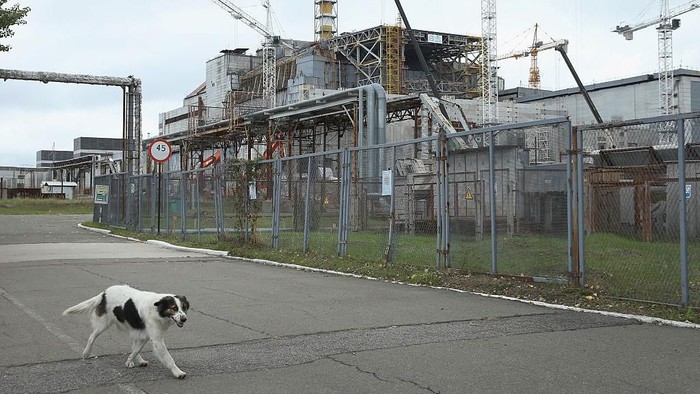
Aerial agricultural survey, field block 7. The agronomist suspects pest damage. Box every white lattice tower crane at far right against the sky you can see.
[612,0,700,115]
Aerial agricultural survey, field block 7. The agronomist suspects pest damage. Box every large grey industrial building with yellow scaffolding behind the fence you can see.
[158,22,546,169]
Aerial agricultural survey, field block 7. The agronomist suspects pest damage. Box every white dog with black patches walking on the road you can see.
[63,285,190,379]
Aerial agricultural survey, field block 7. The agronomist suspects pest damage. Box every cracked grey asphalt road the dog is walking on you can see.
[0,215,700,393]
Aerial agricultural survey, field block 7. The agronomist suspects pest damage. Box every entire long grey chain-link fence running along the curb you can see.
[95,114,700,305]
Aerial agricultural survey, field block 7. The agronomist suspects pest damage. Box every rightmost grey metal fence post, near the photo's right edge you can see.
[676,119,690,306]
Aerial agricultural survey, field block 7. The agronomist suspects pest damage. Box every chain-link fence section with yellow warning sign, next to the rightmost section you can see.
[448,120,571,281]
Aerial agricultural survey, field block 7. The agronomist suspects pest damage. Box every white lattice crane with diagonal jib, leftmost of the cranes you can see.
[212,0,282,108]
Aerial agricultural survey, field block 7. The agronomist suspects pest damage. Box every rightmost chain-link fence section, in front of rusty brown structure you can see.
[578,114,700,305]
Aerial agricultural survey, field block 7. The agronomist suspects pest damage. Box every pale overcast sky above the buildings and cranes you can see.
[0,0,700,167]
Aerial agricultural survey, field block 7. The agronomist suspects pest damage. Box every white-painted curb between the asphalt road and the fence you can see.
[78,224,700,329]
